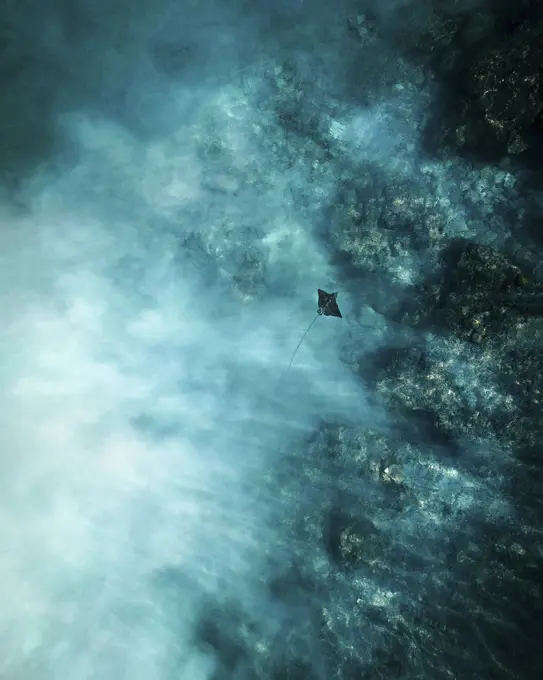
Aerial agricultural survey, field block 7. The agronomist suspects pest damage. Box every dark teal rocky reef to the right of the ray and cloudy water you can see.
[200,2,543,680]
